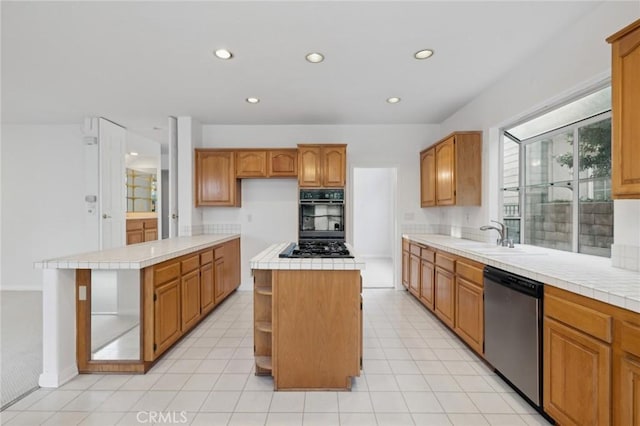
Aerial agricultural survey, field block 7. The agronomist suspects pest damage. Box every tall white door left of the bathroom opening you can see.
[98,118,127,250]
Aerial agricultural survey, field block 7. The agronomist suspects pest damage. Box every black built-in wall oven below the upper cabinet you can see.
[298,189,345,242]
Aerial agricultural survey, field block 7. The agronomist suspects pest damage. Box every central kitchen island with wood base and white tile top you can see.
[251,243,364,390]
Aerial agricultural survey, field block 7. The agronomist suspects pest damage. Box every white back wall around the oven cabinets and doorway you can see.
[199,125,439,289]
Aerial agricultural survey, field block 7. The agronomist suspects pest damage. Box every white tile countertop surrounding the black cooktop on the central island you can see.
[250,243,364,271]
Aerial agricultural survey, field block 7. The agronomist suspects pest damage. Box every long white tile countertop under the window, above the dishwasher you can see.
[403,234,640,313]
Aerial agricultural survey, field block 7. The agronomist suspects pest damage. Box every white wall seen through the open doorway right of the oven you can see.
[352,168,395,257]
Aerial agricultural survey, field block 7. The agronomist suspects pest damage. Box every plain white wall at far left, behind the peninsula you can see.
[1,125,99,290]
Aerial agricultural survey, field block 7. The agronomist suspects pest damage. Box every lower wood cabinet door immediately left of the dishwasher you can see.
[455,277,484,354]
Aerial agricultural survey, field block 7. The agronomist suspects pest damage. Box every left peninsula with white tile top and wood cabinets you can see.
[34,234,240,387]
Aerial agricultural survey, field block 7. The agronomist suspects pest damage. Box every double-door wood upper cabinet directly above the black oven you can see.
[298,144,347,188]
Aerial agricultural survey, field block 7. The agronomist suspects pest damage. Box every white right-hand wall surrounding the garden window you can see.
[440,1,640,258]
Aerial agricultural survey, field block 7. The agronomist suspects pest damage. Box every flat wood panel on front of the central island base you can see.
[272,270,362,390]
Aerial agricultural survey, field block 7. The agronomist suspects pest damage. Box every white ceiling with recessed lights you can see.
[2,1,600,139]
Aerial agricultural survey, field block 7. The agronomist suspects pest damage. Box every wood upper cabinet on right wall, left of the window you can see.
[420,132,482,207]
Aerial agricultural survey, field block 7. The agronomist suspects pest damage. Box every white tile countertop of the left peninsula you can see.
[34,234,240,269]
